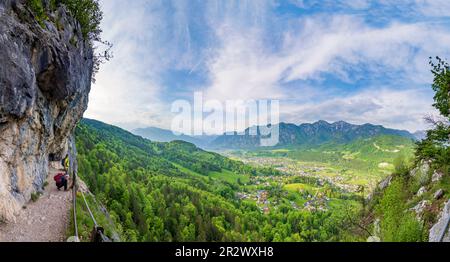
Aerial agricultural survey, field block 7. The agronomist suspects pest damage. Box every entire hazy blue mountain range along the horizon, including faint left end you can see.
[133,120,422,149]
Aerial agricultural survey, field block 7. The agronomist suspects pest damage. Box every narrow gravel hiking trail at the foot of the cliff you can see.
[0,168,72,242]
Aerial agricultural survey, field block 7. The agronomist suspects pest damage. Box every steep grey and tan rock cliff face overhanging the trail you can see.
[0,0,93,221]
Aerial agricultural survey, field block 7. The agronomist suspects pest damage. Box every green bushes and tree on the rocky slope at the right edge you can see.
[370,57,450,242]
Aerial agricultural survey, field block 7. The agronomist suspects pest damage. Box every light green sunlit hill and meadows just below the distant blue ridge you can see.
[243,135,415,185]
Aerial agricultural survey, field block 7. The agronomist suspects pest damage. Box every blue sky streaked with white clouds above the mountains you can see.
[85,0,450,131]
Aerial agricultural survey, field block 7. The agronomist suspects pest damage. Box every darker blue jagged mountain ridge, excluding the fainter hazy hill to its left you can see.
[209,120,416,149]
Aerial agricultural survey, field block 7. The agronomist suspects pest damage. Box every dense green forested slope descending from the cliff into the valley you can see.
[76,119,360,241]
